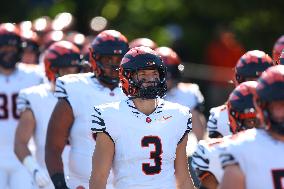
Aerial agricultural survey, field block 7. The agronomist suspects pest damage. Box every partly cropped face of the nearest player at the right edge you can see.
[268,100,284,123]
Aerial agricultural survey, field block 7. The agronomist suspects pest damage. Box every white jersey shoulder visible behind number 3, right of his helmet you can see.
[165,83,204,109]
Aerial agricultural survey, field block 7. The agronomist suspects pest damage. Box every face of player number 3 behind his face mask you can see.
[134,69,160,87]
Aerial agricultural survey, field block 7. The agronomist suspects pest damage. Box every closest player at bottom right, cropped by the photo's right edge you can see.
[220,65,284,189]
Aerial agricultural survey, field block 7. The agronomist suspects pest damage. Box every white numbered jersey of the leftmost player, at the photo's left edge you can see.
[0,63,43,155]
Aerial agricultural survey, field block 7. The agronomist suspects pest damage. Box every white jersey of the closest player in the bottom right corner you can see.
[220,129,284,189]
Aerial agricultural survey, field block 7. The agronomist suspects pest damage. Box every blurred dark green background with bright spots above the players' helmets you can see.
[0,0,284,117]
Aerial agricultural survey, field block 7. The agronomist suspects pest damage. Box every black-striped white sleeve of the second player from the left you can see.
[16,89,31,114]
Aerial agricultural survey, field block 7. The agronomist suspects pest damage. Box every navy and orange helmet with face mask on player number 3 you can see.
[119,47,167,99]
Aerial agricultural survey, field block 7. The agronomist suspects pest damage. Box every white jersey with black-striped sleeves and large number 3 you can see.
[92,99,192,189]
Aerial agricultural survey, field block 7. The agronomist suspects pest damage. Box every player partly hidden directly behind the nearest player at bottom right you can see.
[192,81,259,189]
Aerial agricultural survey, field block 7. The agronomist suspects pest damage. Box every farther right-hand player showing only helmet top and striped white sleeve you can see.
[207,50,274,138]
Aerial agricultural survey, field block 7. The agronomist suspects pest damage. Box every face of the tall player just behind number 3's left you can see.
[100,56,122,78]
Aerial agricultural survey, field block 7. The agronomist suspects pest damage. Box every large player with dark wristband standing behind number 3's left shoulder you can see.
[45,30,129,189]
